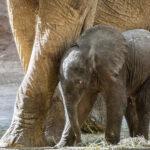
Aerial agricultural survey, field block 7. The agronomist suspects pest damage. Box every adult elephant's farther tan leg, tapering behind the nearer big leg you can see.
[7,0,38,72]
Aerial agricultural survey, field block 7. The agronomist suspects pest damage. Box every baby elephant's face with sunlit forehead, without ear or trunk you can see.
[60,45,90,102]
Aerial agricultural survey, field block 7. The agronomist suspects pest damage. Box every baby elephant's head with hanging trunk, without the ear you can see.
[59,45,90,143]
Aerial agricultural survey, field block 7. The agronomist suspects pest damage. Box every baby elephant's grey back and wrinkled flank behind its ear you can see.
[122,29,150,90]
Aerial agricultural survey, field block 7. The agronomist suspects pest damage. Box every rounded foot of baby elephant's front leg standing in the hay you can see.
[106,133,120,144]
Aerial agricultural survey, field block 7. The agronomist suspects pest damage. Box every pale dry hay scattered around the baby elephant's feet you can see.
[82,134,150,150]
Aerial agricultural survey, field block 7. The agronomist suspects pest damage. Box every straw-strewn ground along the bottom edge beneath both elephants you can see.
[0,134,150,150]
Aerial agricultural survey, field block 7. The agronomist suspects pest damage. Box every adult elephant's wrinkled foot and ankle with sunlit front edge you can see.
[0,114,47,147]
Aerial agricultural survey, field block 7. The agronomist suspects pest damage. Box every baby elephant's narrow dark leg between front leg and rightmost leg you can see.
[125,97,139,137]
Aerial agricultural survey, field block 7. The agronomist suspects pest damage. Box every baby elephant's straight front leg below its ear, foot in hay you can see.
[105,82,126,144]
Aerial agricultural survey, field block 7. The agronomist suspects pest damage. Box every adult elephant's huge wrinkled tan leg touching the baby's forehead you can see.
[0,0,96,147]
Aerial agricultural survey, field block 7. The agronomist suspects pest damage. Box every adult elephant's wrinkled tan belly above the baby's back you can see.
[94,0,150,31]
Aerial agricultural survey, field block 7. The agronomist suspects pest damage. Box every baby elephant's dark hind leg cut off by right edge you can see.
[136,79,150,139]
